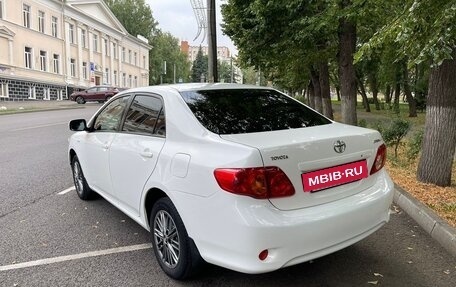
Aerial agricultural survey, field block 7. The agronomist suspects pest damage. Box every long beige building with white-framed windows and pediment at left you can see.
[0,0,151,101]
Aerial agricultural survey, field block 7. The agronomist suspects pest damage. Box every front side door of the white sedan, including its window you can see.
[82,96,130,197]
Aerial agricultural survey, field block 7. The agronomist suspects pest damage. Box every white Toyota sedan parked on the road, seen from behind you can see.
[69,84,393,279]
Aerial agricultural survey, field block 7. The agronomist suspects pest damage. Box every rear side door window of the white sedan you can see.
[122,95,166,136]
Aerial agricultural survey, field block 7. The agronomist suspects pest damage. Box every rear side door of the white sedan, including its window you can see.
[110,94,166,216]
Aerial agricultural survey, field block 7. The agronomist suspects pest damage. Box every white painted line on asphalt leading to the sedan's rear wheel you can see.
[0,243,152,271]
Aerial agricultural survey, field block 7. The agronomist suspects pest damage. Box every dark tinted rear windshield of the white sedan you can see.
[181,89,331,134]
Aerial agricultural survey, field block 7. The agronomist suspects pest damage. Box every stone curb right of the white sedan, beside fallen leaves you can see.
[394,184,456,257]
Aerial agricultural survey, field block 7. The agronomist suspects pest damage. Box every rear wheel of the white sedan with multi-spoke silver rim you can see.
[150,197,204,280]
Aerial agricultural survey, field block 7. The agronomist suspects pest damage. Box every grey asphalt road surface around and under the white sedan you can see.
[0,107,456,287]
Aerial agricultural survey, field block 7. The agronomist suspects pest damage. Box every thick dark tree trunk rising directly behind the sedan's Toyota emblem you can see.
[338,0,358,125]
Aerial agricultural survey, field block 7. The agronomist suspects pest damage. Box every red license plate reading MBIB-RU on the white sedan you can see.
[301,160,367,192]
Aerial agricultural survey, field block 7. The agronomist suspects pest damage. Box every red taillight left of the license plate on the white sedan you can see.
[214,167,295,199]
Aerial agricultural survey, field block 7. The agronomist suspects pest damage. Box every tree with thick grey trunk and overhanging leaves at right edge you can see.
[357,0,456,186]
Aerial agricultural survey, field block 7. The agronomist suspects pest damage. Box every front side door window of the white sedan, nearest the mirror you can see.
[93,96,130,131]
